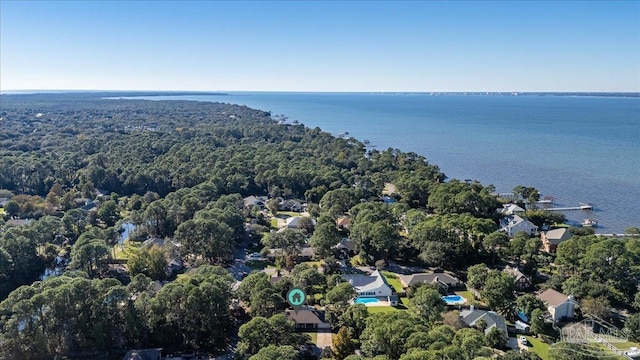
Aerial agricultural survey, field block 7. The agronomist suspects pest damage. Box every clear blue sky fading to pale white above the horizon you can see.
[0,0,640,92]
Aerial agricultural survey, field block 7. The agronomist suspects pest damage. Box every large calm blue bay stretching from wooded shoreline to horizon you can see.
[127,92,640,233]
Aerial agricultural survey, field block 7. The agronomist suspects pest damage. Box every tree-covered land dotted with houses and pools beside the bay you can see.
[0,92,640,360]
